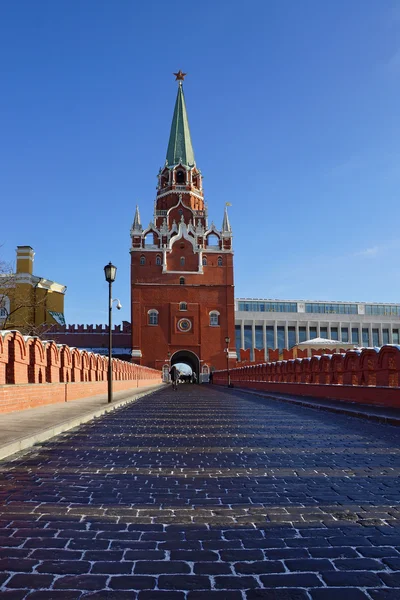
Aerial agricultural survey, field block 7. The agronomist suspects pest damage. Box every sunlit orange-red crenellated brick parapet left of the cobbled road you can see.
[0,331,161,413]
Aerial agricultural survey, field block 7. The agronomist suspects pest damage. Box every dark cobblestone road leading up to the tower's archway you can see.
[0,385,400,600]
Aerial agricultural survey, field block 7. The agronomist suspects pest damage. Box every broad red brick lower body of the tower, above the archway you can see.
[131,252,236,369]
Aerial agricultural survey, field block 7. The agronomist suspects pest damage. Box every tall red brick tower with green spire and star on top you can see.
[130,71,236,380]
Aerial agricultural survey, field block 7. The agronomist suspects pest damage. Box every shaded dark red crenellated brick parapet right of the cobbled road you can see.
[213,345,400,408]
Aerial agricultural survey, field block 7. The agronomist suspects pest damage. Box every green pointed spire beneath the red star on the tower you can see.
[167,81,195,167]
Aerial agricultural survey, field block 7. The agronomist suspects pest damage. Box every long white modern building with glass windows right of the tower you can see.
[235,298,400,360]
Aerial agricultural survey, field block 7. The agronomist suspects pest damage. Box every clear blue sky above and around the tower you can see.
[0,0,400,323]
